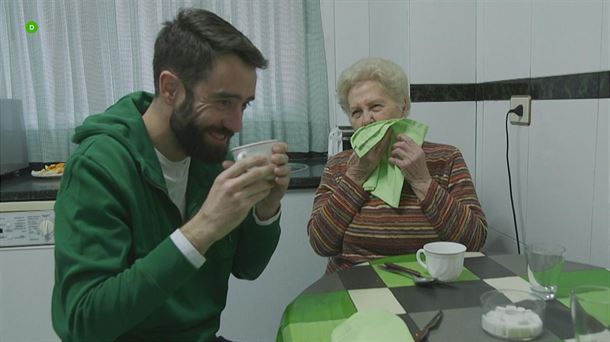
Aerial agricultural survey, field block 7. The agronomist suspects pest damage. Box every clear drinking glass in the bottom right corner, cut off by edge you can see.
[570,285,610,342]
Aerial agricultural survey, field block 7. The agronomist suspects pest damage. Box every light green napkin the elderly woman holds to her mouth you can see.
[351,119,428,208]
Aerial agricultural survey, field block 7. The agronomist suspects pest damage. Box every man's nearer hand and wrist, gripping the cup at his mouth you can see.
[180,157,274,255]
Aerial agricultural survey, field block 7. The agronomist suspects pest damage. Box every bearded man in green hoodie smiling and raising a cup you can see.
[52,9,290,341]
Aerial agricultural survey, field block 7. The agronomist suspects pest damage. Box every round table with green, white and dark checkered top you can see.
[277,252,610,342]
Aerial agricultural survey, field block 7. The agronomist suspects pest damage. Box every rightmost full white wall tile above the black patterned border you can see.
[532,0,603,77]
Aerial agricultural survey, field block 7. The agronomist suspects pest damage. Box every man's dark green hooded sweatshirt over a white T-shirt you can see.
[52,92,280,341]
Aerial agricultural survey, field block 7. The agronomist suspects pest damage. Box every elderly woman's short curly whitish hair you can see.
[337,57,411,115]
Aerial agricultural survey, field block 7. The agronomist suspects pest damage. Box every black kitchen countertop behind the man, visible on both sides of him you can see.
[0,156,326,202]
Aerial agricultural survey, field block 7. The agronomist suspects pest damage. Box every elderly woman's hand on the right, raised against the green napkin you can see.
[389,134,432,201]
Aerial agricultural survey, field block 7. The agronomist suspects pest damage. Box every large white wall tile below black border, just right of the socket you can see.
[525,100,598,262]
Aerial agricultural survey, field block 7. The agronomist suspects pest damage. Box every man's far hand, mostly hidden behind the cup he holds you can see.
[256,142,290,221]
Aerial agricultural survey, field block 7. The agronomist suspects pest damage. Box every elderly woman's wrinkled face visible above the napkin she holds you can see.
[347,81,407,130]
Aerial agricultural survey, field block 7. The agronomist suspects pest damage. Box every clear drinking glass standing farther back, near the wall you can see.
[525,243,566,300]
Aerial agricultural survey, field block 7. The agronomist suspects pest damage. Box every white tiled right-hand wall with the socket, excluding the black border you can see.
[477,0,610,267]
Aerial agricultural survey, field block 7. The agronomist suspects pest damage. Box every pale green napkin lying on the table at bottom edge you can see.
[330,310,413,342]
